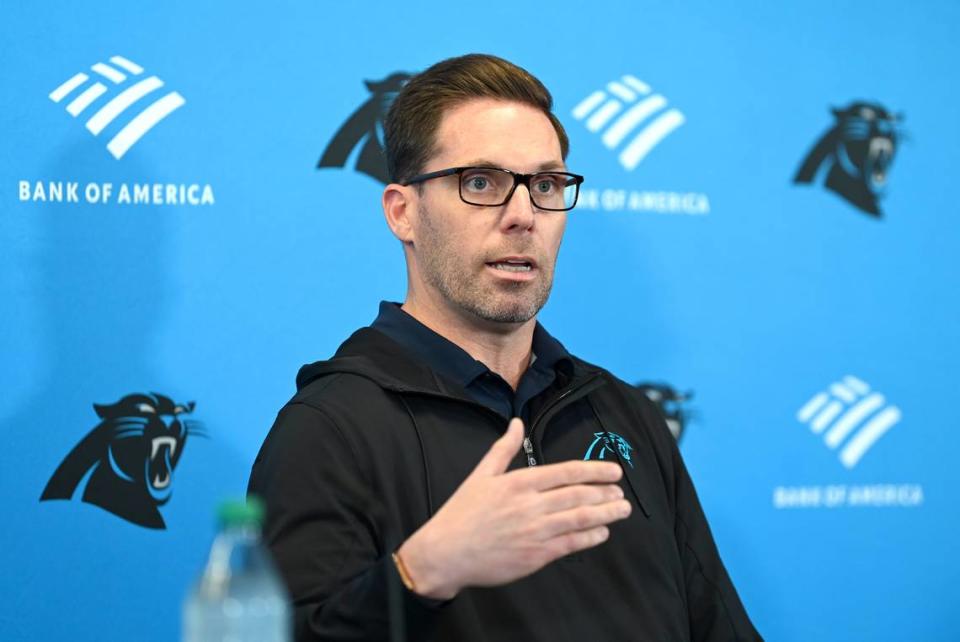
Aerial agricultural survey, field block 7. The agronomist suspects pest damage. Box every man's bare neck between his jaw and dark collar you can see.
[400,296,537,390]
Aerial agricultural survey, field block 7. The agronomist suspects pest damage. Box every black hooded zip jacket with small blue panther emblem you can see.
[249,328,760,642]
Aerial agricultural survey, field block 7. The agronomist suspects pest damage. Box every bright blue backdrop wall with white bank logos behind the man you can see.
[0,0,960,641]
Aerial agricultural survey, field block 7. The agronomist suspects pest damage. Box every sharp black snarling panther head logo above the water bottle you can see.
[40,393,203,528]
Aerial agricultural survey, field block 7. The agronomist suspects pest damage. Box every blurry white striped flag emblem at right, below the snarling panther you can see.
[797,375,900,468]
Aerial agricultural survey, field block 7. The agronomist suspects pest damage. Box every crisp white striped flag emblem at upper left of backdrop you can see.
[50,56,187,160]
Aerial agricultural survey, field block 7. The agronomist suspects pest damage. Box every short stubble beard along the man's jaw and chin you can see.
[418,204,553,323]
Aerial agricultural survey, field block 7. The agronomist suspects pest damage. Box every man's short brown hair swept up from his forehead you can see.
[384,54,570,183]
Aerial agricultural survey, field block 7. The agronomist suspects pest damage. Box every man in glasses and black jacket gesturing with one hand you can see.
[249,55,759,642]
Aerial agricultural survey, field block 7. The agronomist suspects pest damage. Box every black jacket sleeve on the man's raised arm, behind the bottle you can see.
[247,403,438,642]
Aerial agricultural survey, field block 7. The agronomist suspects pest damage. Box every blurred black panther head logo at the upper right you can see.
[793,102,903,218]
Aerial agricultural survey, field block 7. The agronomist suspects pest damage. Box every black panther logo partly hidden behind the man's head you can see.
[317,72,410,185]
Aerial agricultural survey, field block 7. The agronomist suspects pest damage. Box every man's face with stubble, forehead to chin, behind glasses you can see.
[411,99,566,323]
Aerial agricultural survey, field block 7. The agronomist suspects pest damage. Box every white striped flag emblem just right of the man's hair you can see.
[573,75,686,171]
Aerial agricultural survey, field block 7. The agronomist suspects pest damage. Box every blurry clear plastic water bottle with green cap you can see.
[183,499,292,642]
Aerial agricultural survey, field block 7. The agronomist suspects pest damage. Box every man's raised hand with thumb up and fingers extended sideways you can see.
[397,419,631,599]
